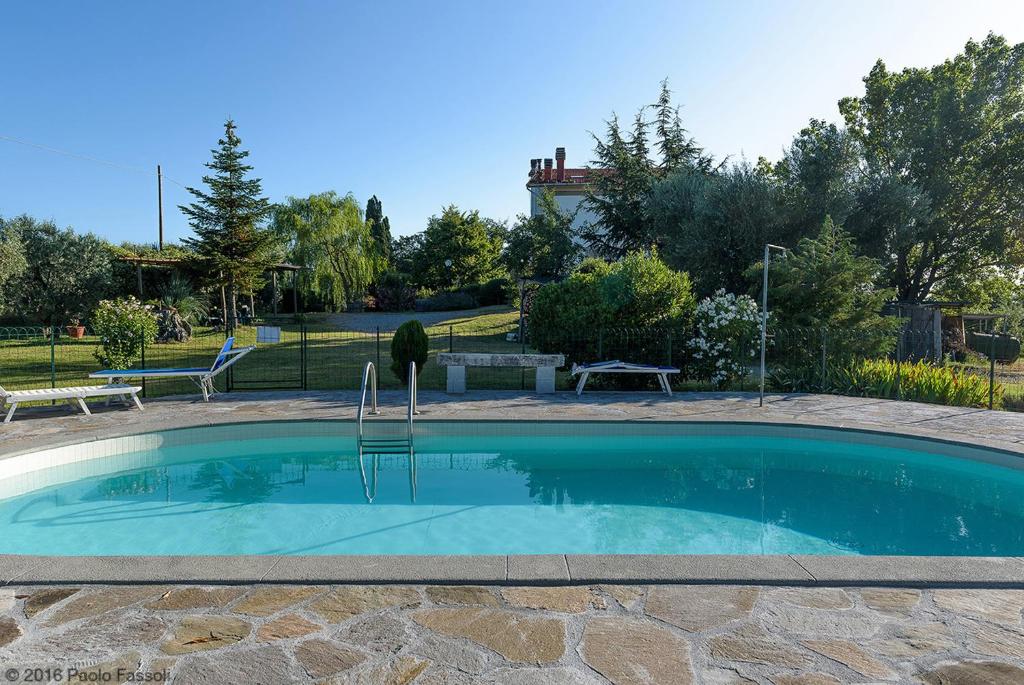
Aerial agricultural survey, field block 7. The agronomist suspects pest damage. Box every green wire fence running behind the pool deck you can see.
[0,319,1024,411]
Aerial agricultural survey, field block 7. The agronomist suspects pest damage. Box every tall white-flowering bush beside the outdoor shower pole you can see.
[688,290,761,388]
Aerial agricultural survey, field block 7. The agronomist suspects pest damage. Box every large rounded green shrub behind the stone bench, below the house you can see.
[527,252,695,370]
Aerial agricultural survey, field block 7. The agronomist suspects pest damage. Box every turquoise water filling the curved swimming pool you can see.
[0,422,1024,556]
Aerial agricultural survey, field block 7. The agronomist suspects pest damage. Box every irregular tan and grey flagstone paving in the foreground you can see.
[0,585,1024,685]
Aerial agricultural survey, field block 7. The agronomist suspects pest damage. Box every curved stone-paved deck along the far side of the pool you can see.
[6,390,1024,458]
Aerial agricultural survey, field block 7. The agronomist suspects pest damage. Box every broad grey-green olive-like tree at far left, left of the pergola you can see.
[2,215,113,326]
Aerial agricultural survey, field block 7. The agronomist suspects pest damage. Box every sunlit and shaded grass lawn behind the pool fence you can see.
[0,307,567,397]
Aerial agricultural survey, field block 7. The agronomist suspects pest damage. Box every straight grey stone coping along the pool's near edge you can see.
[0,554,1024,588]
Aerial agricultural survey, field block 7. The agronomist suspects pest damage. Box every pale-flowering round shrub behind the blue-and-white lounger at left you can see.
[91,296,157,369]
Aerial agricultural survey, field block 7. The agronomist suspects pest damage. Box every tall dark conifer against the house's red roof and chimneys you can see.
[583,81,713,259]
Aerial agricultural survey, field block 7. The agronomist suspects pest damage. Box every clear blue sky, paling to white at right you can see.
[0,0,1024,242]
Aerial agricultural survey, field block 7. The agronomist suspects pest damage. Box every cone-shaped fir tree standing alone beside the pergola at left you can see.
[179,119,280,322]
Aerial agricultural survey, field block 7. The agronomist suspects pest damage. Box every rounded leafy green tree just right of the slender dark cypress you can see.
[412,205,506,289]
